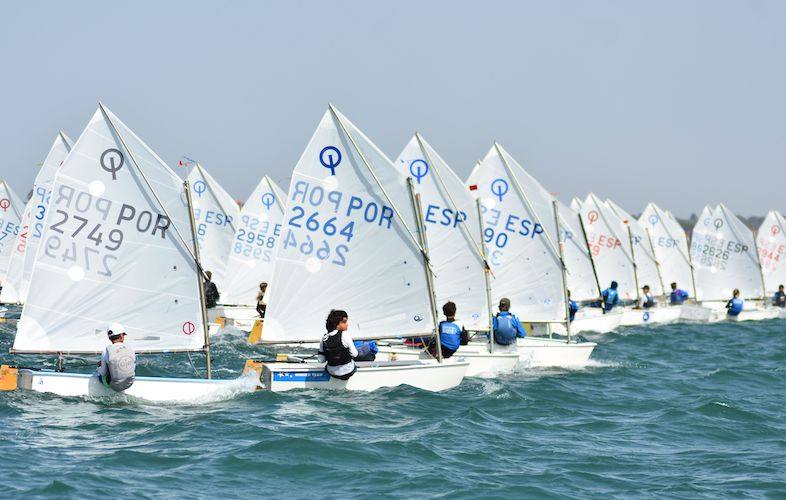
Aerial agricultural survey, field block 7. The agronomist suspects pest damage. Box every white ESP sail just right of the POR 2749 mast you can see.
[188,163,240,288]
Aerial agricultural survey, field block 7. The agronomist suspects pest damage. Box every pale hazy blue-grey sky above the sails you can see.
[0,0,786,216]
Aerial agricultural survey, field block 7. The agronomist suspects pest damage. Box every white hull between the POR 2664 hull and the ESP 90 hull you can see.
[377,344,519,377]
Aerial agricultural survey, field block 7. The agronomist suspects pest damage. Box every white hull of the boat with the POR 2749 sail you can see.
[18,369,258,402]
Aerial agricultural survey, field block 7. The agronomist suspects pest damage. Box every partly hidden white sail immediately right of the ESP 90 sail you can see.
[559,202,600,301]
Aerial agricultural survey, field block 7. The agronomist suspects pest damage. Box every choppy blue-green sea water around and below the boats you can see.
[0,320,786,498]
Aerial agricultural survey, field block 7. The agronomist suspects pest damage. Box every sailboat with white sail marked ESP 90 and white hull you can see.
[467,143,595,367]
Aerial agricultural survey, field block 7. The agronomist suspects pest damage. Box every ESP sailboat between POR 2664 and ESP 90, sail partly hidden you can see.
[380,133,519,377]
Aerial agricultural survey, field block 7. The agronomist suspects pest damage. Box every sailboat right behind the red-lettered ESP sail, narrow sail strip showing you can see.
[606,199,682,326]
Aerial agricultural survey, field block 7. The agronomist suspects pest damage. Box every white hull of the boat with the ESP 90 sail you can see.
[466,337,597,368]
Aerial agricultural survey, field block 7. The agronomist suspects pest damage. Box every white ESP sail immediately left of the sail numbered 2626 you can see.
[639,203,696,296]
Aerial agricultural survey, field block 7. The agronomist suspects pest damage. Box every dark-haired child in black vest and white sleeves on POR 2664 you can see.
[317,309,358,380]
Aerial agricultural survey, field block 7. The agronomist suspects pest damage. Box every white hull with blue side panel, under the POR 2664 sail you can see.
[262,358,469,392]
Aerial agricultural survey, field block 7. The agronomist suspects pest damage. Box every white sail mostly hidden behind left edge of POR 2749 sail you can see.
[7,132,73,302]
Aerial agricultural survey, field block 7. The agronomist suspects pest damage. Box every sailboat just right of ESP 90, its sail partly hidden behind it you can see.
[552,203,622,335]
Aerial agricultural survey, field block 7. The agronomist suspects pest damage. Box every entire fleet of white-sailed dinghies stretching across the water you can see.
[0,105,786,401]
